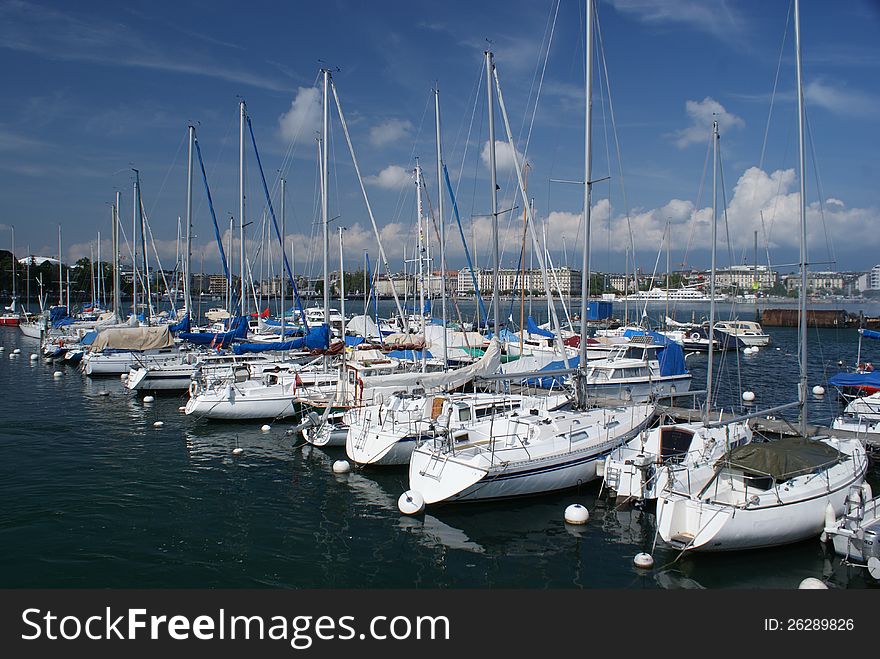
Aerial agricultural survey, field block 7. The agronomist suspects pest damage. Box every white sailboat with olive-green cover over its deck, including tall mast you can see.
[657,0,868,551]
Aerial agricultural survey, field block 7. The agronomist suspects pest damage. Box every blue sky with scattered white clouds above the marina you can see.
[0,0,880,276]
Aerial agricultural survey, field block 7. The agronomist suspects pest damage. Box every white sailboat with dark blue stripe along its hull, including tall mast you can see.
[409,6,655,505]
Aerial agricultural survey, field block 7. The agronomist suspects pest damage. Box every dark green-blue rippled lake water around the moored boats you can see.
[0,303,880,588]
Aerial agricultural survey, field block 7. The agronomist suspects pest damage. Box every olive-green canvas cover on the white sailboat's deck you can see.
[716,437,844,482]
